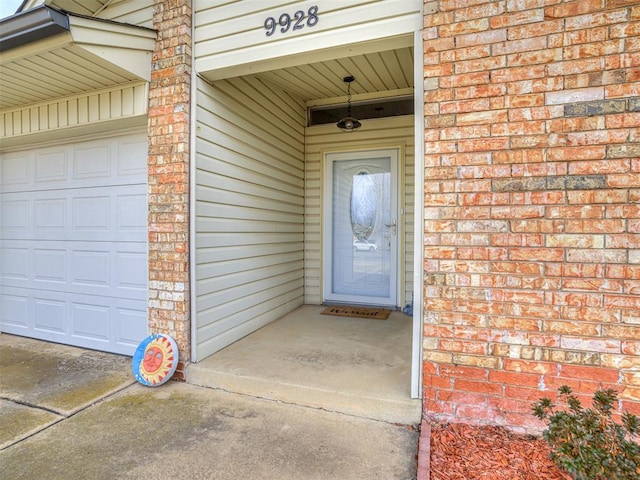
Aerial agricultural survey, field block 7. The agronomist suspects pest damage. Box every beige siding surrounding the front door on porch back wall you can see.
[304,115,415,307]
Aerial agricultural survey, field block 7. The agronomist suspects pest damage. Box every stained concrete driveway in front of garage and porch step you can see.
[0,335,418,480]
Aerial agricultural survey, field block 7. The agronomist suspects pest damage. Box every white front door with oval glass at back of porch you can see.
[323,149,398,307]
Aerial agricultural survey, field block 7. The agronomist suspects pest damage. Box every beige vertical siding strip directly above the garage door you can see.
[0,82,148,145]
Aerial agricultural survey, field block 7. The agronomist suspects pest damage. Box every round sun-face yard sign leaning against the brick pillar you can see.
[131,333,178,387]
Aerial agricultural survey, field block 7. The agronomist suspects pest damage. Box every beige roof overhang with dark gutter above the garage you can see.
[0,5,156,110]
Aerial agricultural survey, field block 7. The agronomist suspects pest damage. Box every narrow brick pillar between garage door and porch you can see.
[148,0,191,379]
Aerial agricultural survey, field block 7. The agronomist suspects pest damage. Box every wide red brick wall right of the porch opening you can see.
[423,0,640,436]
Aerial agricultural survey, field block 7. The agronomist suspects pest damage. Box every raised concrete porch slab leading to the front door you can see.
[186,305,422,425]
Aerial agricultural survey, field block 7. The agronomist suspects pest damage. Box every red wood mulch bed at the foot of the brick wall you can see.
[430,424,570,480]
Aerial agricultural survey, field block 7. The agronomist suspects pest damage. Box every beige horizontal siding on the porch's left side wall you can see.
[195,78,305,360]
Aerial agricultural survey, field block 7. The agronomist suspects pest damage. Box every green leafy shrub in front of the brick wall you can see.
[533,386,640,480]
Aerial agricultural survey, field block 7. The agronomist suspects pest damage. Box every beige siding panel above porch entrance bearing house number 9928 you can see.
[194,0,422,78]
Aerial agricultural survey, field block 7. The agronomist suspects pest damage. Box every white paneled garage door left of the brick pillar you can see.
[0,133,147,355]
